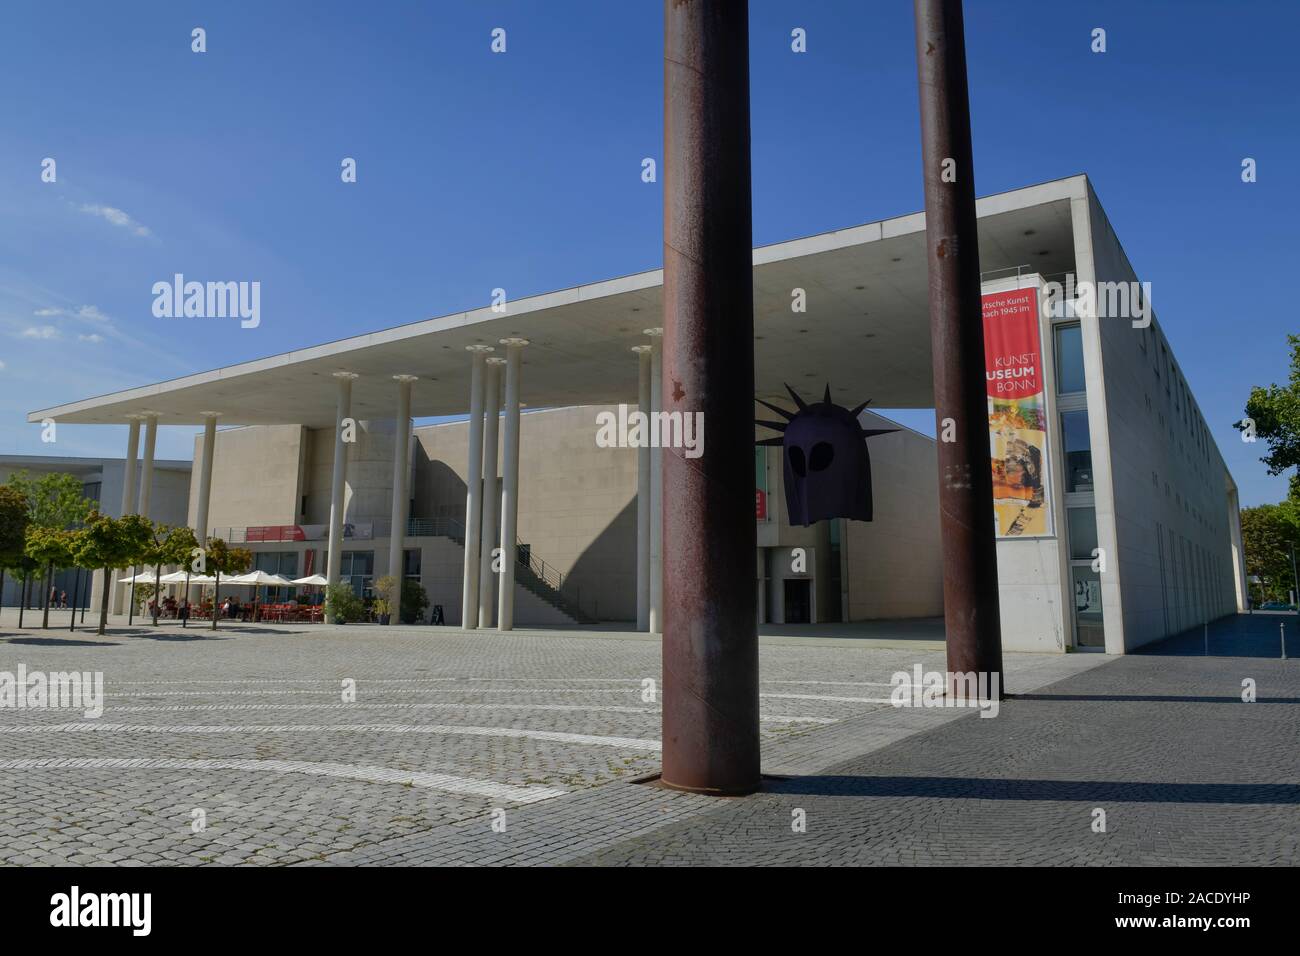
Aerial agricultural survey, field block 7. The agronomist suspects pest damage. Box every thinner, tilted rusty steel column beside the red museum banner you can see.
[915,0,1002,693]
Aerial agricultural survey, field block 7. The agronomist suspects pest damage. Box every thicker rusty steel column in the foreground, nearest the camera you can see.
[662,0,759,795]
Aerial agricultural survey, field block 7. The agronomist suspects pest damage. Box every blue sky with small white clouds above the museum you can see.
[0,0,1300,505]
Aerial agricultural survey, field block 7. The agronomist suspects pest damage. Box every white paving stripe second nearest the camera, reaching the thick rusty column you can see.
[0,723,660,752]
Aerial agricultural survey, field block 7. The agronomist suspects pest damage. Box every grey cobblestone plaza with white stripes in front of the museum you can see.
[0,609,1300,866]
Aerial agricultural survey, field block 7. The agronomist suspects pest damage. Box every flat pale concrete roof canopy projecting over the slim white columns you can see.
[27,176,1087,428]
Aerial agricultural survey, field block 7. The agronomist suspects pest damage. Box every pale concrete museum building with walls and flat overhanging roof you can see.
[29,176,1244,654]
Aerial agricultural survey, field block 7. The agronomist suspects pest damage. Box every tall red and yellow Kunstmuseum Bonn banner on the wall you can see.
[983,289,1053,538]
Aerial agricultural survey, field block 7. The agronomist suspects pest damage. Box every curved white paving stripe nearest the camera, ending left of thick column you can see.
[0,757,567,804]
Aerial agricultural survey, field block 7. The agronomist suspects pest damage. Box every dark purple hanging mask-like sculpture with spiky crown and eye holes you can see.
[755,385,898,527]
